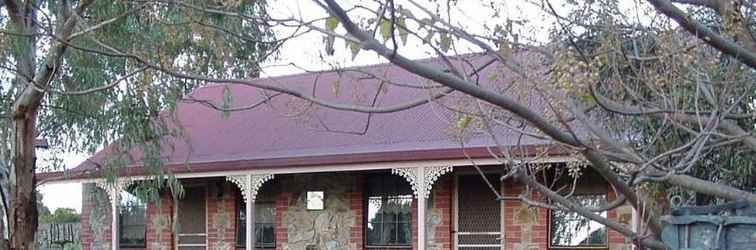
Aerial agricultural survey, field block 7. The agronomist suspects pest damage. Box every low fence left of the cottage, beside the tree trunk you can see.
[35,222,81,250]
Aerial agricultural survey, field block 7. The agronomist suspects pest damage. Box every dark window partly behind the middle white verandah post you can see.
[236,197,276,248]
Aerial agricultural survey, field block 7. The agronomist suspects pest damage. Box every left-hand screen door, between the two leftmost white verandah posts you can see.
[176,186,207,250]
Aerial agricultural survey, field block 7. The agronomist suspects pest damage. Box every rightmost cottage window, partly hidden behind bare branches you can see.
[549,194,607,248]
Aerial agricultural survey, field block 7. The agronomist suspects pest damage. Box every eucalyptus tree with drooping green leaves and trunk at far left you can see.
[0,0,279,249]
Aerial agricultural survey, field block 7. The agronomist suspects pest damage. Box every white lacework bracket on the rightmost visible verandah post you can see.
[391,166,453,198]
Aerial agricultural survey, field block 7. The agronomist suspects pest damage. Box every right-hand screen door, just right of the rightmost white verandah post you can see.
[454,174,501,250]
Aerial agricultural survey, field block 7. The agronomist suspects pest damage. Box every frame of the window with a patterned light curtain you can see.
[362,173,415,249]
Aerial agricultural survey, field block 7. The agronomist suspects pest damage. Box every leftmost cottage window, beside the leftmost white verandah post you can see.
[118,191,147,247]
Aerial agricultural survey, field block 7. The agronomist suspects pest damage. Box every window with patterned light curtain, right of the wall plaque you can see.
[365,175,412,247]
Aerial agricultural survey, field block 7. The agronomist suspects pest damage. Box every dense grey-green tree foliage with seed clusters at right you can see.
[554,1,756,205]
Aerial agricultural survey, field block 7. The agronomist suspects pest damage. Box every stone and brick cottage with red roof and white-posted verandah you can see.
[38,53,635,250]
